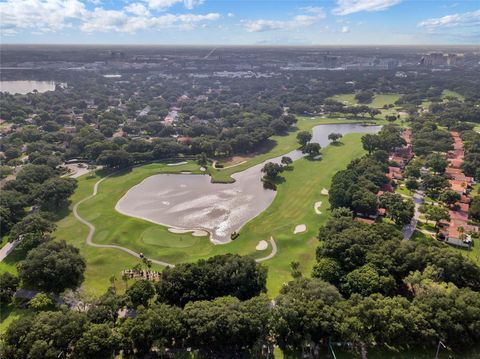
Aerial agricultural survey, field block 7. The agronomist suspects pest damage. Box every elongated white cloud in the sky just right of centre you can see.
[243,7,325,32]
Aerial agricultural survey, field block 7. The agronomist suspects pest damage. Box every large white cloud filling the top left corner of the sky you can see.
[0,0,87,34]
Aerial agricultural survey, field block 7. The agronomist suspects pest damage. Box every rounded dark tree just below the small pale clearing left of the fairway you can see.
[36,177,77,210]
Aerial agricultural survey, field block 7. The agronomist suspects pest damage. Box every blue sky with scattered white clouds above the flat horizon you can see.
[0,0,480,45]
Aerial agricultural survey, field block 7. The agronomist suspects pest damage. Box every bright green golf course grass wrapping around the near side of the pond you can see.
[55,134,364,296]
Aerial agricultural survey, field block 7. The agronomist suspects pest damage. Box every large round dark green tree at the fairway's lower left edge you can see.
[18,241,85,293]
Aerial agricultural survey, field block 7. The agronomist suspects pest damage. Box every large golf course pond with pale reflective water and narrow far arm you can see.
[115,124,381,244]
